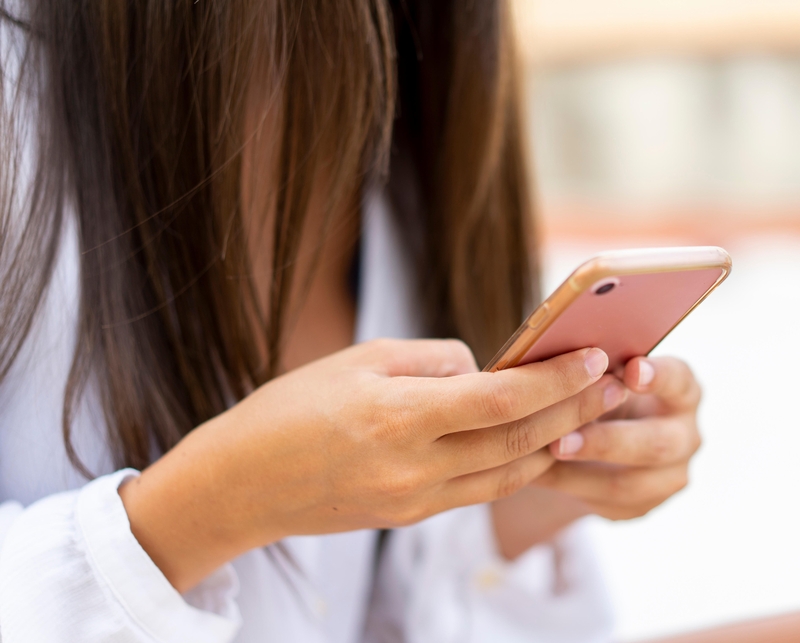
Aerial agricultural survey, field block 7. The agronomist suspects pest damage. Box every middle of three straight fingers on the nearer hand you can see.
[440,376,628,477]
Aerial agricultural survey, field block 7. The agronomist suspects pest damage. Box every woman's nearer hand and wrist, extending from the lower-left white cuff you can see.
[120,340,626,591]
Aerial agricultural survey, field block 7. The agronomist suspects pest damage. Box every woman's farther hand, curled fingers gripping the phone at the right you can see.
[533,357,701,520]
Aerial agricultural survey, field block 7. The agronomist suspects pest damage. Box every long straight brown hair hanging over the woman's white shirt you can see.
[0,0,536,475]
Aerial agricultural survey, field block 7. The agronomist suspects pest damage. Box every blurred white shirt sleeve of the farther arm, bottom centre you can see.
[365,505,613,643]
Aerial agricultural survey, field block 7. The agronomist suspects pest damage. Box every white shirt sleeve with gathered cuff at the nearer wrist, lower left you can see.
[0,469,241,643]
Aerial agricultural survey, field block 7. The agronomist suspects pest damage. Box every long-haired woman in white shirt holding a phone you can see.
[0,0,699,643]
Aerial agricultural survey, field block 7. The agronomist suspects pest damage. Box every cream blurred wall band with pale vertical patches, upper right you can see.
[529,56,800,214]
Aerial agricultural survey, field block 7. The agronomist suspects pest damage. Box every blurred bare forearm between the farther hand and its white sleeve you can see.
[492,486,589,560]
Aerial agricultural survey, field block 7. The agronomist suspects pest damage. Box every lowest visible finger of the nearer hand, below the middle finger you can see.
[440,450,554,511]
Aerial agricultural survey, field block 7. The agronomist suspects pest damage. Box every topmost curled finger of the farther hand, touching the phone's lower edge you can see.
[623,357,701,410]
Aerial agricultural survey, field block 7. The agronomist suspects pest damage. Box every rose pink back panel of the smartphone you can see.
[518,268,724,370]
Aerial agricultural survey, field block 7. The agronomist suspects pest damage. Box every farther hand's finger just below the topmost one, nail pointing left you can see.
[550,414,700,467]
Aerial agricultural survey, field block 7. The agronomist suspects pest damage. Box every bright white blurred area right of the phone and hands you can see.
[545,236,800,643]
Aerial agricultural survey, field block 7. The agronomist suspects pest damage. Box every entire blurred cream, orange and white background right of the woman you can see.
[514,0,800,641]
